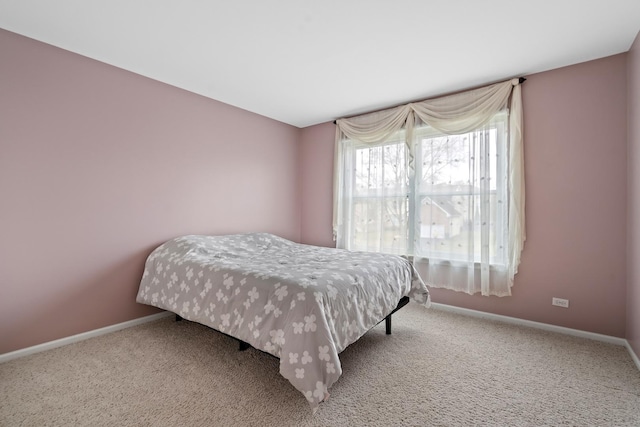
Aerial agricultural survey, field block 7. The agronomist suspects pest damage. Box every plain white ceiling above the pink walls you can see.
[0,0,640,127]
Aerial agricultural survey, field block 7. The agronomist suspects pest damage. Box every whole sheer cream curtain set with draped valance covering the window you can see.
[334,79,525,296]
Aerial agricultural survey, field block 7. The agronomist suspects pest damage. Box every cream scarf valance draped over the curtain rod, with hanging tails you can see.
[333,78,525,295]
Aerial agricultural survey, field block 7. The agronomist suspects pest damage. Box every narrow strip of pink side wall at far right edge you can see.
[627,33,640,356]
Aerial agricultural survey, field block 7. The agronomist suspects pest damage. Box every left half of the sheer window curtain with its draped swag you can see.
[333,106,413,254]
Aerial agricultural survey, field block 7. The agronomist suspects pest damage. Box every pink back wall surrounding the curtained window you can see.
[301,54,640,337]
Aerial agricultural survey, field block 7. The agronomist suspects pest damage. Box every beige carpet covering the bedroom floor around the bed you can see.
[0,304,640,426]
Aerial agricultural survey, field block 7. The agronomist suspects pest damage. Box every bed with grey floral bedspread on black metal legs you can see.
[136,233,429,411]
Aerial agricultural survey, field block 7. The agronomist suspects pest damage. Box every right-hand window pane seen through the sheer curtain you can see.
[415,125,507,263]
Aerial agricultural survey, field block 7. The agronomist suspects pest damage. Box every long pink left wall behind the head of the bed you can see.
[0,30,301,353]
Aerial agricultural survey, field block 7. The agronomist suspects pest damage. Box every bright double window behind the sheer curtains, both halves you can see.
[343,114,507,264]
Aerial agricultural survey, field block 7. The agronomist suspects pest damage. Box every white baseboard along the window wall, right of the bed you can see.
[431,303,640,350]
